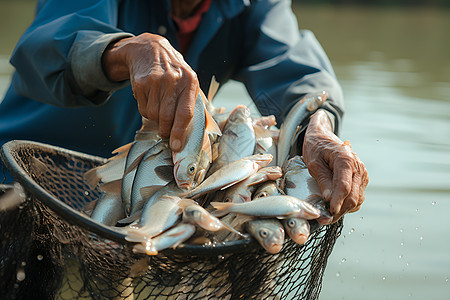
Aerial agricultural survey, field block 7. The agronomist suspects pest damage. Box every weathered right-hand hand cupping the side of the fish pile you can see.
[303,110,369,225]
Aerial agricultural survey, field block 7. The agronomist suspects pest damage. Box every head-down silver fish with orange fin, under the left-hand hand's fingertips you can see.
[172,93,221,190]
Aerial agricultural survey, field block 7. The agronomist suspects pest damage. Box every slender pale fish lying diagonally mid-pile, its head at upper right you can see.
[183,154,273,198]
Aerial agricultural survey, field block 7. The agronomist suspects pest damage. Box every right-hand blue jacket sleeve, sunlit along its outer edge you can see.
[235,0,344,133]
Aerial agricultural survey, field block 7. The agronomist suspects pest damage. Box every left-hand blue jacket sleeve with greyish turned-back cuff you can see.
[11,0,132,107]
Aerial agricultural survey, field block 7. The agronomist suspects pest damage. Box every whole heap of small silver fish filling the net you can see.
[85,88,331,255]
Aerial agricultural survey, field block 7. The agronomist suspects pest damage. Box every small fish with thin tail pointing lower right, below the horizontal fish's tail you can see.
[183,201,245,238]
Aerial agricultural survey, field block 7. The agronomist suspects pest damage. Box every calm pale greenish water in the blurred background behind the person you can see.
[0,1,450,300]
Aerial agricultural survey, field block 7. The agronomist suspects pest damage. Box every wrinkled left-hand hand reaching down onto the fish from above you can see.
[102,33,199,151]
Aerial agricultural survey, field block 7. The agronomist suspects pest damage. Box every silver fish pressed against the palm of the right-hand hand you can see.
[280,155,333,224]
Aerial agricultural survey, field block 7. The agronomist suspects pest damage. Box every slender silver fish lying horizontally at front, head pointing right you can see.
[211,195,320,220]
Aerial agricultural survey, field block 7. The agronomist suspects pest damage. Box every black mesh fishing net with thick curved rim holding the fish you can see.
[0,141,342,299]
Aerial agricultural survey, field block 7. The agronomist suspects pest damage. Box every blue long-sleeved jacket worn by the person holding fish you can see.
[0,0,343,181]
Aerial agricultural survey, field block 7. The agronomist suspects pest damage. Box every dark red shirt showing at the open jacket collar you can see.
[172,0,212,54]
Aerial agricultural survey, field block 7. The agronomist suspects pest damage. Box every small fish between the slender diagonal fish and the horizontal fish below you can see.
[223,166,283,203]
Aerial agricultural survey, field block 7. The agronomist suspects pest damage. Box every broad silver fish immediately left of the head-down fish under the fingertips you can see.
[130,140,173,214]
